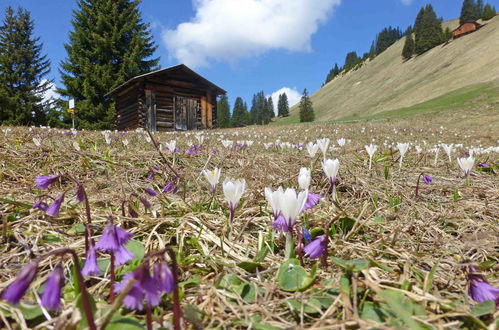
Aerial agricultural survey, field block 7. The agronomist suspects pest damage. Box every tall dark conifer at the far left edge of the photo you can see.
[0,6,52,125]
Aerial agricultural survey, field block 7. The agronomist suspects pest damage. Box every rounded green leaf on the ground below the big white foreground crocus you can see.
[277,258,317,292]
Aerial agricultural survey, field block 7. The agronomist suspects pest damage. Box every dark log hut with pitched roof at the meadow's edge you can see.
[107,64,225,131]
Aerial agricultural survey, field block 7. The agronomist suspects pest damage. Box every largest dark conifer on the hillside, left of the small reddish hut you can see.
[414,5,444,54]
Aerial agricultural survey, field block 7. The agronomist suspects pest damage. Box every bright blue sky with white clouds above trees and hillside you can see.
[0,0,499,111]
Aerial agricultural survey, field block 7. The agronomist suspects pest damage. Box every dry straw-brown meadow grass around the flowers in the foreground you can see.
[0,122,499,329]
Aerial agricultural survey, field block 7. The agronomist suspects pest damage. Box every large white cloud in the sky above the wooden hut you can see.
[162,0,341,67]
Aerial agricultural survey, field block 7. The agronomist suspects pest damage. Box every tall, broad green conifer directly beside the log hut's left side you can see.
[59,0,159,129]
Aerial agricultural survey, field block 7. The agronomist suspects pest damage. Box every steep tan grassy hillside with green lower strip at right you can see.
[277,17,499,124]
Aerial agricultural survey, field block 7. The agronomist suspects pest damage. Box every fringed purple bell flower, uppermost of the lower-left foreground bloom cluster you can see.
[95,223,134,266]
